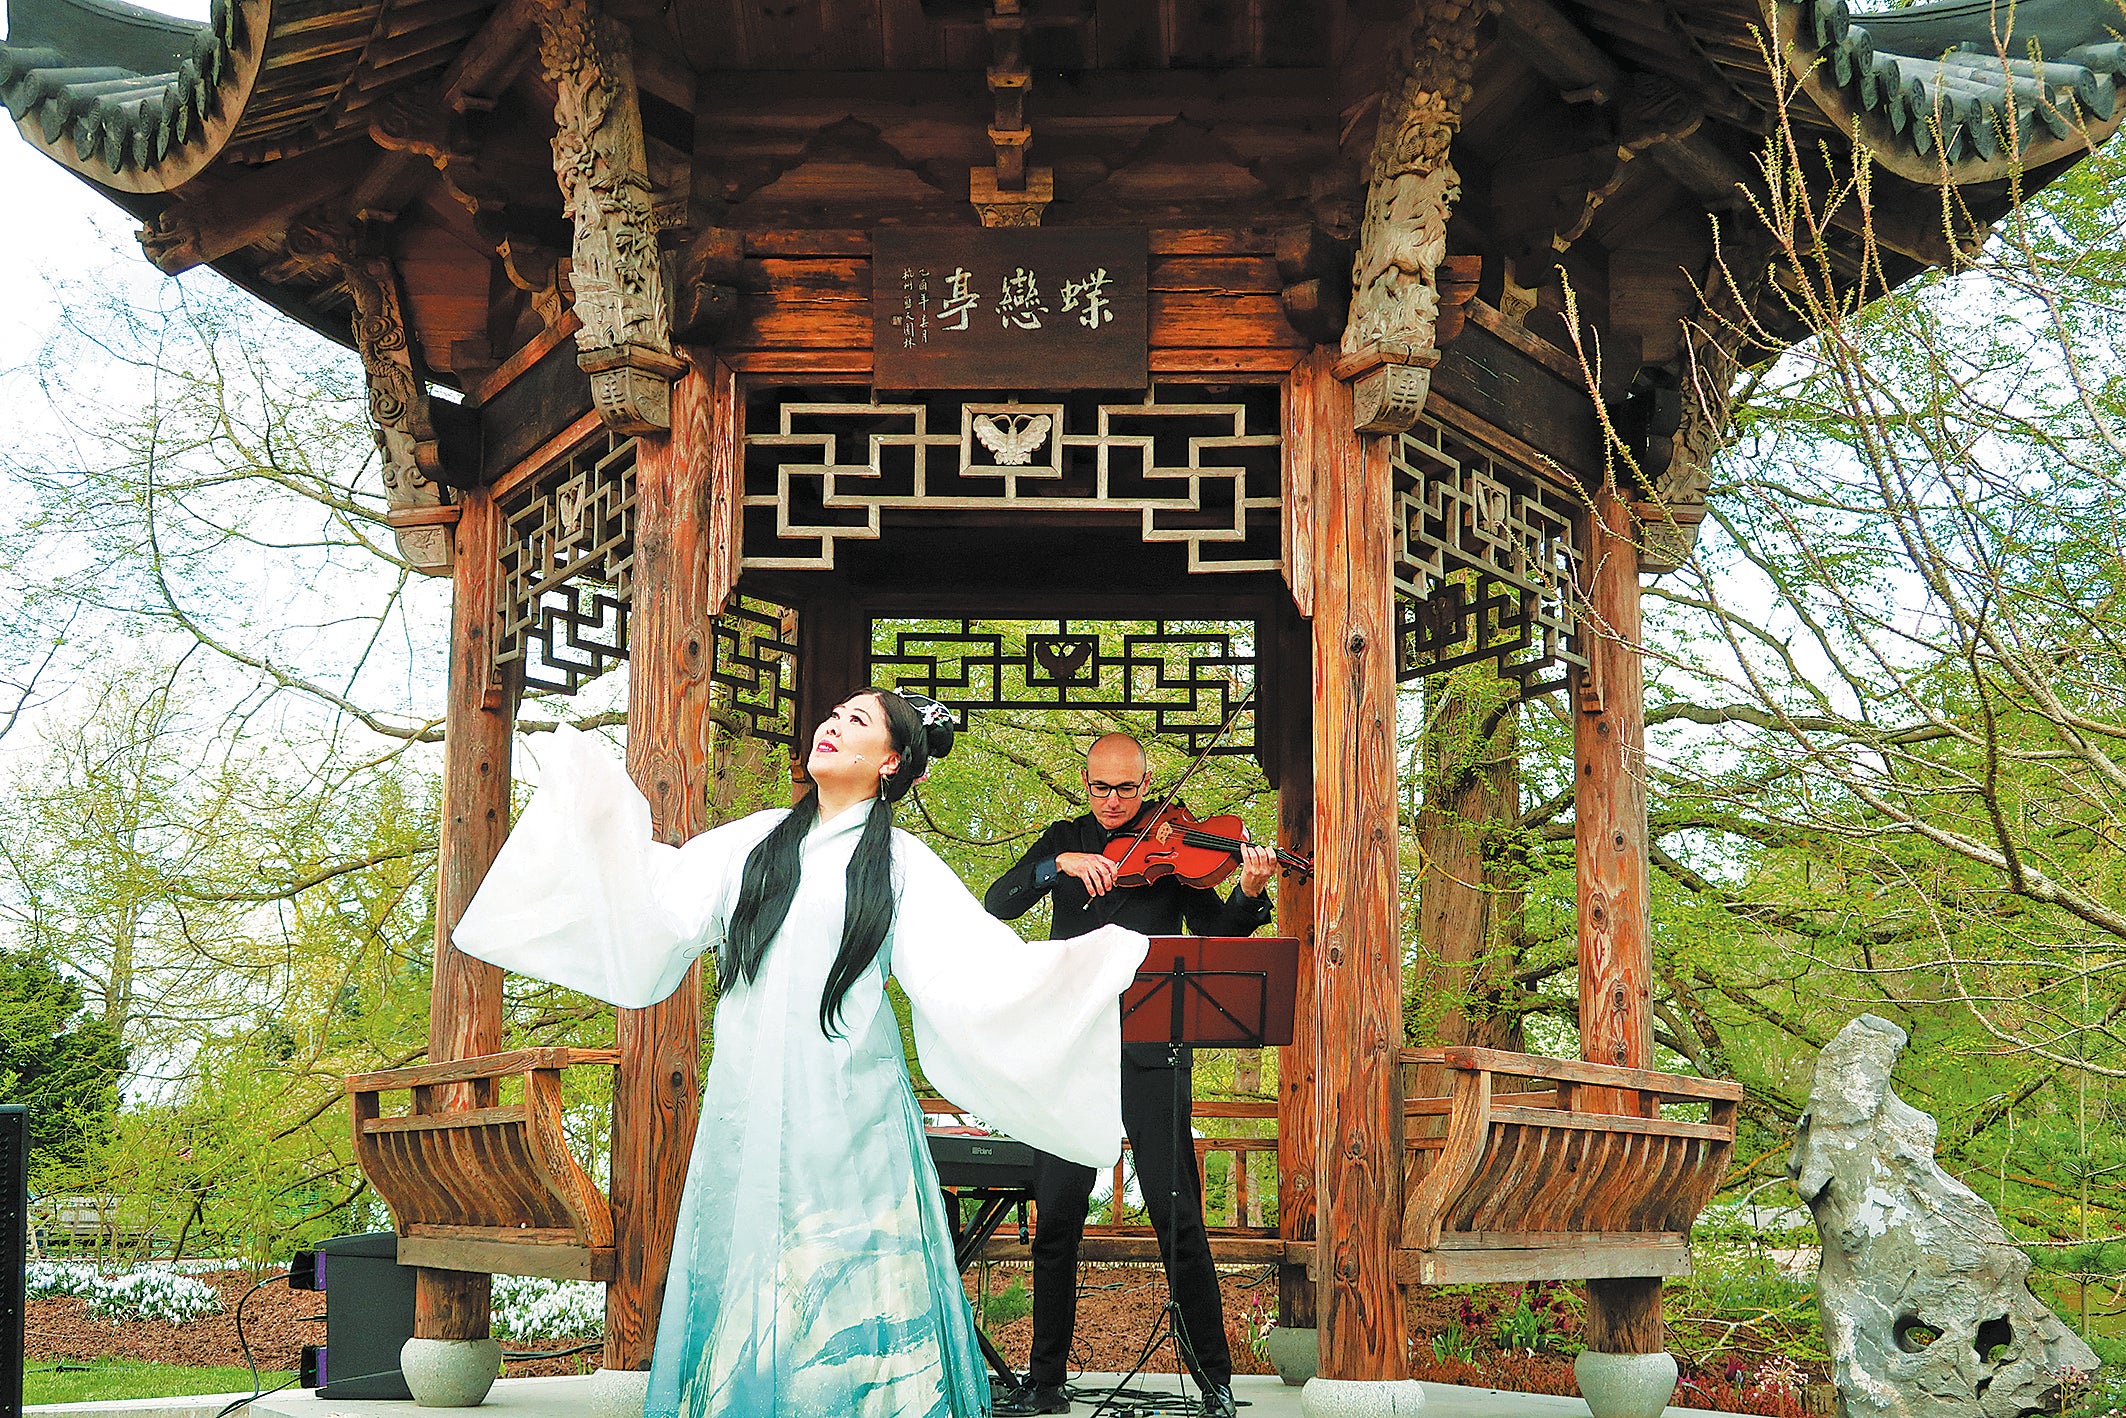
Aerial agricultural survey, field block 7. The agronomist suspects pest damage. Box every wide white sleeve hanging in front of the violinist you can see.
[893,833,1150,1167]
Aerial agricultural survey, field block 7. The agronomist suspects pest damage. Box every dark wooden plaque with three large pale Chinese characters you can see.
[872,227,1148,389]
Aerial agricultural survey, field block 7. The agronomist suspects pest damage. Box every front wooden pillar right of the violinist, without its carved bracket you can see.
[1314,370,1407,1382]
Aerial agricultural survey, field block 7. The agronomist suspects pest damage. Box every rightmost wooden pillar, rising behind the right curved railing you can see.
[1573,487,1665,1354]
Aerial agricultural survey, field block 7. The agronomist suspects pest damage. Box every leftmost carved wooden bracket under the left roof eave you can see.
[281,213,451,576]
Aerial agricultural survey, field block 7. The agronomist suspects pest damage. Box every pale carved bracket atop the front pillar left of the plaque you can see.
[538,0,685,434]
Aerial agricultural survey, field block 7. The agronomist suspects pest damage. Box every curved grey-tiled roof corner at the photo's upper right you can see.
[1777,0,2126,183]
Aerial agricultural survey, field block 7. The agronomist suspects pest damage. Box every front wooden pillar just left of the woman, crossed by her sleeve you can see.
[604,364,727,1369]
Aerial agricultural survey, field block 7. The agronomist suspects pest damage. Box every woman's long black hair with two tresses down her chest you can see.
[716,685,952,1037]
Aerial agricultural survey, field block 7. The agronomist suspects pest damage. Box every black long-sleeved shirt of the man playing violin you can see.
[982,804,1271,1065]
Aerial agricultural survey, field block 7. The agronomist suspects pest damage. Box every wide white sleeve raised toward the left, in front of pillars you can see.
[451,727,782,1010]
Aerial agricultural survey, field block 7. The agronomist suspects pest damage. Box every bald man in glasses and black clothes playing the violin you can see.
[982,733,1278,1418]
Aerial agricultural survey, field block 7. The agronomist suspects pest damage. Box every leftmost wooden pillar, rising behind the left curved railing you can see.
[412,491,517,1339]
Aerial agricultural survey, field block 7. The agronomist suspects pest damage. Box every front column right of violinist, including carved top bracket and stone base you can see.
[1310,0,1480,1414]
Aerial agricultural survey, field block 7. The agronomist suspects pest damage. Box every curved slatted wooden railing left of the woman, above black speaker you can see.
[347,1048,621,1280]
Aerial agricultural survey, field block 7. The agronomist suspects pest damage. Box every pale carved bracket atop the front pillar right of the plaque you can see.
[1344,0,1482,434]
